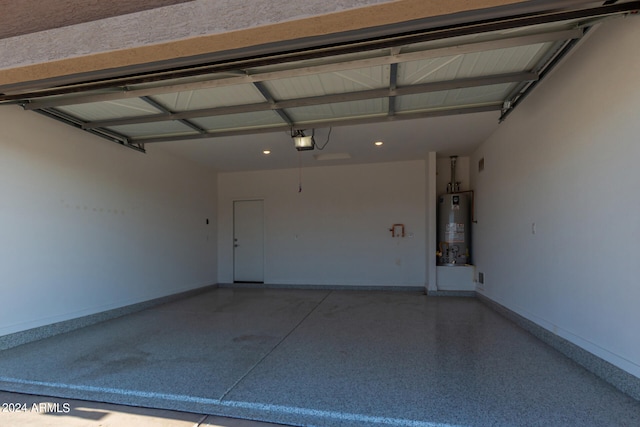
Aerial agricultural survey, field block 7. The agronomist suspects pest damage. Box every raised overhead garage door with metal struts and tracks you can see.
[0,2,640,151]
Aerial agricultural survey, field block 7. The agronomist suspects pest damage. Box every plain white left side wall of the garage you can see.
[0,106,217,335]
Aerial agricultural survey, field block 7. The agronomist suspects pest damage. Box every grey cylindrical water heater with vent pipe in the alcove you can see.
[436,156,471,266]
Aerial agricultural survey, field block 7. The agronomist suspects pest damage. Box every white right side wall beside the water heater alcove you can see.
[471,18,640,377]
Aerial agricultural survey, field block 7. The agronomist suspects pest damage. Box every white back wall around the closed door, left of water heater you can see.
[218,160,426,286]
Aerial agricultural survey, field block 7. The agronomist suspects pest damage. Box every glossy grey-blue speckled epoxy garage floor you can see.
[0,288,640,427]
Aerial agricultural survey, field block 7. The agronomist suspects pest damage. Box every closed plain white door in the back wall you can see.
[233,200,264,283]
